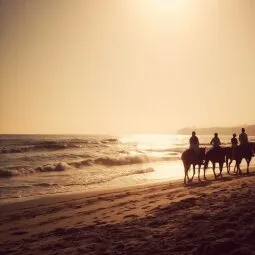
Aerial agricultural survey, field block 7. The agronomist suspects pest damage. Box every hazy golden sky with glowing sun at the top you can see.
[0,0,255,134]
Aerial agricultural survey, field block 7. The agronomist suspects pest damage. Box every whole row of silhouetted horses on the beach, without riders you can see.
[181,143,255,184]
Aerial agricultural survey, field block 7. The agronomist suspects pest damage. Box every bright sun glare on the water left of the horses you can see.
[120,134,187,182]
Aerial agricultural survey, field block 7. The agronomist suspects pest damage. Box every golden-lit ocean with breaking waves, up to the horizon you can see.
[0,134,255,203]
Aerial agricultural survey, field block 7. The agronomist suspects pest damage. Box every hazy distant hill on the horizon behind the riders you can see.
[178,125,255,136]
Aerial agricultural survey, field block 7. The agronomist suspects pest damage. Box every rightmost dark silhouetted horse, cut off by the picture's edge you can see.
[235,143,255,174]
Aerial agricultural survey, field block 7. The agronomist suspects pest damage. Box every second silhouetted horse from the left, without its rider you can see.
[204,147,225,179]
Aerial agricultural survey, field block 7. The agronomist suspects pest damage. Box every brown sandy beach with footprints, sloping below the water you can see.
[0,172,255,255]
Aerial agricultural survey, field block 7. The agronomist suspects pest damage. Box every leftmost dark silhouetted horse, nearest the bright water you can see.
[181,148,205,184]
